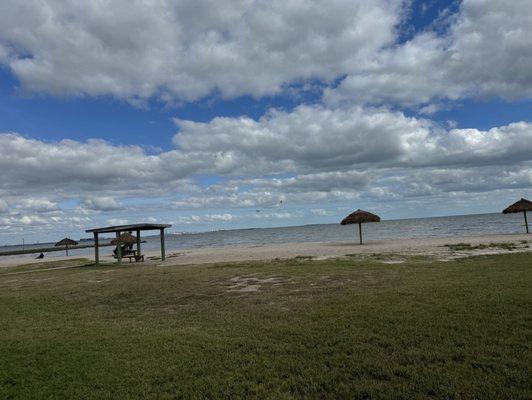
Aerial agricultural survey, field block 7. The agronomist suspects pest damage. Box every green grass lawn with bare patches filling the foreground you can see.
[0,253,532,399]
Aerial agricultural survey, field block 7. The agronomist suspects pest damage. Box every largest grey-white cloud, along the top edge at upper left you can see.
[0,0,402,101]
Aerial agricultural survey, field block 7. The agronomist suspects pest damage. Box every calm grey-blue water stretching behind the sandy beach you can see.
[0,213,524,258]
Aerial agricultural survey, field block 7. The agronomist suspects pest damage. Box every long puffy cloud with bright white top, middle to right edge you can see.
[174,105,532,173]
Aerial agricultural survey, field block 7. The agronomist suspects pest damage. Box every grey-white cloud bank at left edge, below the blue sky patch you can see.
[0,133,198,197]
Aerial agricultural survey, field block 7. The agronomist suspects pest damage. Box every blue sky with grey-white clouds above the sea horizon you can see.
[0,0,532,245]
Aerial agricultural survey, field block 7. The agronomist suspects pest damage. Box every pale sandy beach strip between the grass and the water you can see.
[0,234,532,267]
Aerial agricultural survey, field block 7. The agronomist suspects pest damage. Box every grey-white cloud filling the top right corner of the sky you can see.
[325,0,532,106]
